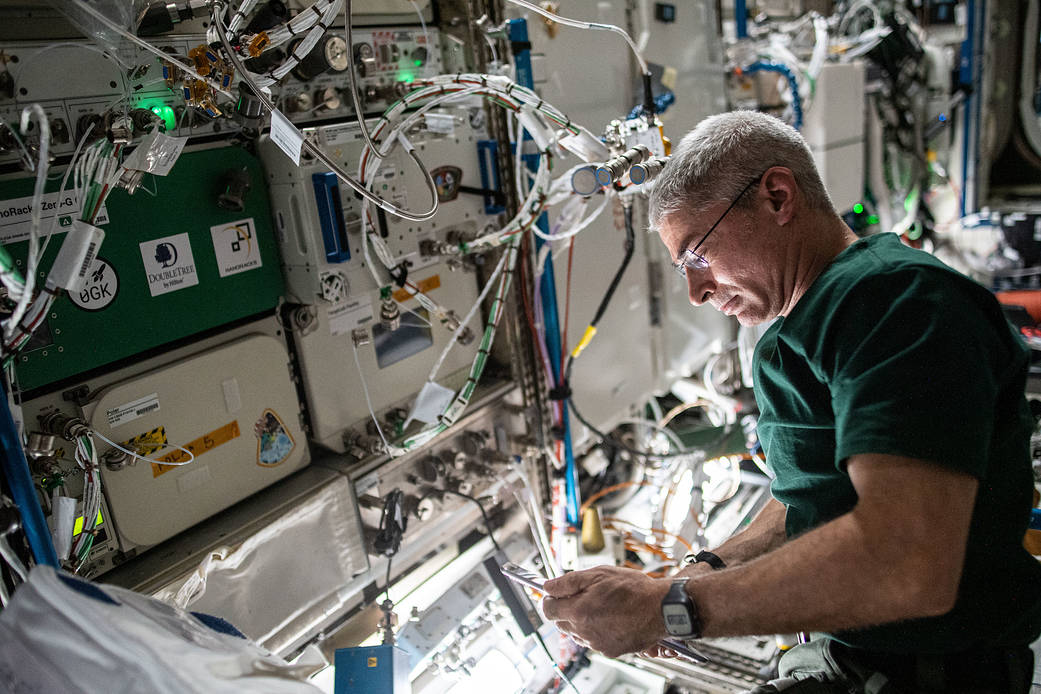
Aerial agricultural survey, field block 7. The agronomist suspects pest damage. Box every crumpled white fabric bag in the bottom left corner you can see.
[0,566,321,694]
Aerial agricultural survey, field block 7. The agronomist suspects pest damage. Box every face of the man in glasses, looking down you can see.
[659,202,786,326]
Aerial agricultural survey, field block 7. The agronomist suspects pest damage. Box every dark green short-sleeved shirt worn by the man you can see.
[755,234,1041,653]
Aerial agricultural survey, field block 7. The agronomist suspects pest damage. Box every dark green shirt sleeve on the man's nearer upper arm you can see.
[818,267,1015,478]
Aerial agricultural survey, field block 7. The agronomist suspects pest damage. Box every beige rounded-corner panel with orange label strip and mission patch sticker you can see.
[87,335,310,549]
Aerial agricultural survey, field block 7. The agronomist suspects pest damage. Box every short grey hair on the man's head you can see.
[650,110,835,229]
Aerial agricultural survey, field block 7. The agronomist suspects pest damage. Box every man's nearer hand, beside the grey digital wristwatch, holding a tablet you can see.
[542,566,671,658]
